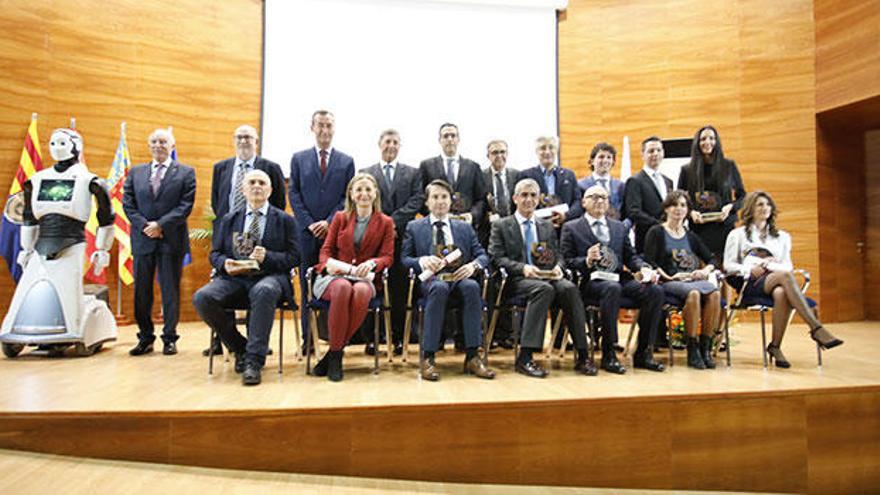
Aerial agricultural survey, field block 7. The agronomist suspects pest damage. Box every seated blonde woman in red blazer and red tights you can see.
[312,173,394,382]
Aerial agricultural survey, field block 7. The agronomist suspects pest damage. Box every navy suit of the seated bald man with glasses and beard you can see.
[560,215,663,360]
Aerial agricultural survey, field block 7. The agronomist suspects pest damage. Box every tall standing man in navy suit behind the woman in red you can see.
[289,110,354,346]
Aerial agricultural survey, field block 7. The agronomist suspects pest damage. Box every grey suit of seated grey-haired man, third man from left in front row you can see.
[489,215,587,351]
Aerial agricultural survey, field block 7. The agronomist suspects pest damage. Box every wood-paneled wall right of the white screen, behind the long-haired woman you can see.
[559,0,821,300]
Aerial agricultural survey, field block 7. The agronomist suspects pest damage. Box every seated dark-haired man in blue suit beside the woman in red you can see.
[400,180,495,381]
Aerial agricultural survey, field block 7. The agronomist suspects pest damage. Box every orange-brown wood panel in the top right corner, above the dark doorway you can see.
[812,0,880,112]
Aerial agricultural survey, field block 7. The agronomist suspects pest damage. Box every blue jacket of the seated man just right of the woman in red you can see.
[400,217,489,273]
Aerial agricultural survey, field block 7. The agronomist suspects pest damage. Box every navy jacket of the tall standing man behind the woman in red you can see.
[290,147,354,236]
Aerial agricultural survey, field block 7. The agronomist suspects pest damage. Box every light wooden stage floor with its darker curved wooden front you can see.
[0,321,880,493]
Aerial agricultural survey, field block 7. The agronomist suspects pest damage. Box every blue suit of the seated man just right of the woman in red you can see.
[400,217,489,353]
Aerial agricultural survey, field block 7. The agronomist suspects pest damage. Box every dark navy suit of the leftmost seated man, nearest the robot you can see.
[193,205,299,366]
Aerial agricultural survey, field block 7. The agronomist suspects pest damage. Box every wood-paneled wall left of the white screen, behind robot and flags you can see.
[0,0,262,319]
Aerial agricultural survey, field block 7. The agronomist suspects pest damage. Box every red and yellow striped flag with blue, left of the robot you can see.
[0,114,43,283]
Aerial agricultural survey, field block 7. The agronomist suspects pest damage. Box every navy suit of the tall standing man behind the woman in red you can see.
[289,147,354,338]
